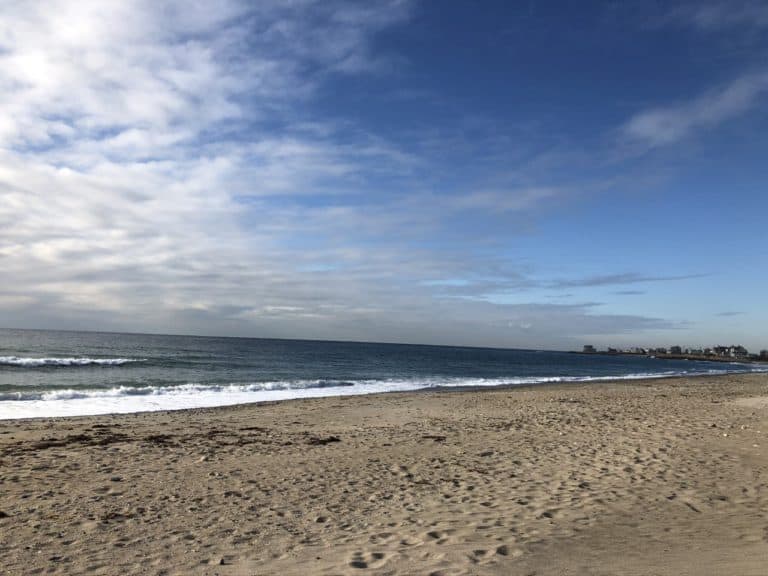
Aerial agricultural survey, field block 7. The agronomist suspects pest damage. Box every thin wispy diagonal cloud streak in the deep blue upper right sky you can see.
[622,71,768,148]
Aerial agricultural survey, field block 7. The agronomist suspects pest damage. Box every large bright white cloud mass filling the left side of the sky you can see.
[0,0,414,313]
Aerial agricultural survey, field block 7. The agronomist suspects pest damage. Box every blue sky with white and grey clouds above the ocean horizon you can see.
[0,0,768,351]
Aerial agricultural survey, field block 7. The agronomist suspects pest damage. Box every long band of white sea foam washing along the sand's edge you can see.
[0,367,768,420]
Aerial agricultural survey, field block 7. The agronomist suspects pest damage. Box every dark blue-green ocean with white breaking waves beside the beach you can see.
[0,330,766,419]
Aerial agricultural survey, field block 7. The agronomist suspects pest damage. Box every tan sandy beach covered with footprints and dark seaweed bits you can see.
[0,375,768,576]
